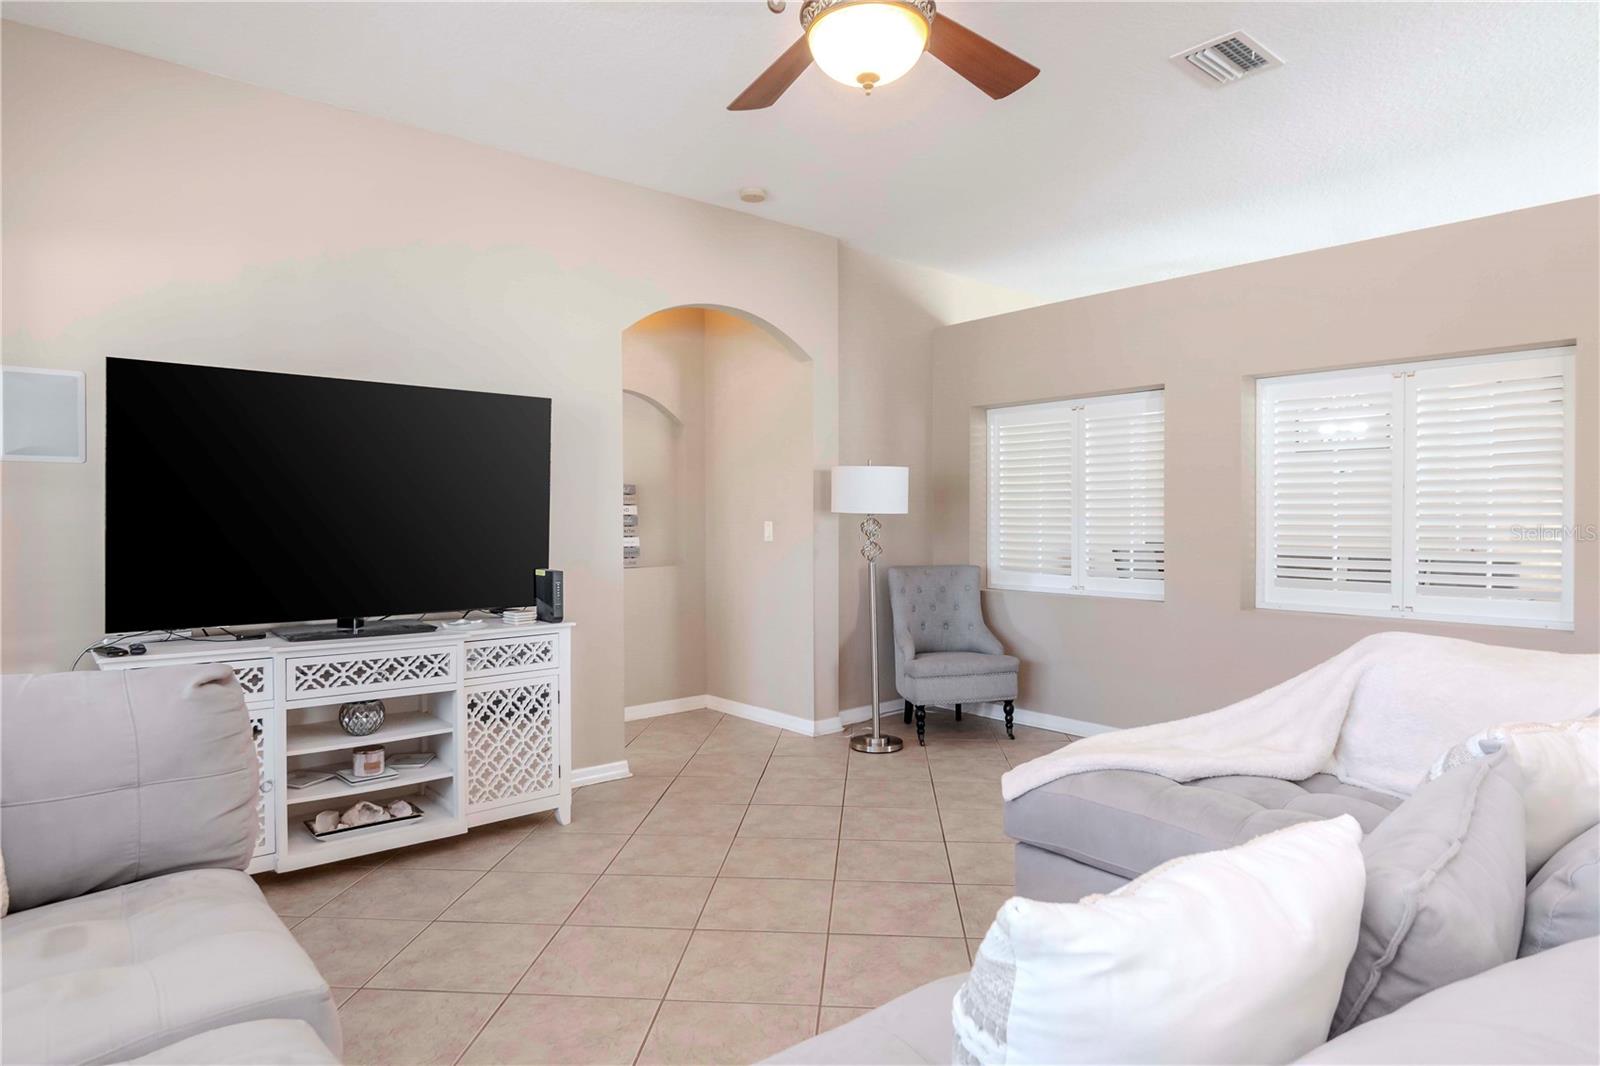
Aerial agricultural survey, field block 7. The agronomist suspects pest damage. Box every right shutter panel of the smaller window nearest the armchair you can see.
[1082,392,1166,594]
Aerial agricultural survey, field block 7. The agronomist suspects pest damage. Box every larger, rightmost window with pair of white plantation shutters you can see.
[1256,349,1573,629]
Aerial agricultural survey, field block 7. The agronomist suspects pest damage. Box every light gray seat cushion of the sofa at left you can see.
[0,869,341,1063]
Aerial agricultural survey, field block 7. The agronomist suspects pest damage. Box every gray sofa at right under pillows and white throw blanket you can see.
[768,758,1600,1066]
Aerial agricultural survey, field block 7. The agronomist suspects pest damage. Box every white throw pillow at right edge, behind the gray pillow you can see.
[1427,714,1600,877]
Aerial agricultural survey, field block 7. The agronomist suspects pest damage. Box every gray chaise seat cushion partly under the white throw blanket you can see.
[1005,770,1400,877]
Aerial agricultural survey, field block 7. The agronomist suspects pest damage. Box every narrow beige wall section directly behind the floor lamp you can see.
[822,245,1038,709]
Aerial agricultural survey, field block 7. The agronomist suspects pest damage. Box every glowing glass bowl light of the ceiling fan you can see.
[800,0,934,93]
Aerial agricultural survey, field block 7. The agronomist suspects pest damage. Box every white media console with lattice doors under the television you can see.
[94,621,573,874]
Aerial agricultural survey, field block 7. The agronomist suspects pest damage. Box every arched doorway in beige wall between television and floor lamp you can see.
[622,306,816,731]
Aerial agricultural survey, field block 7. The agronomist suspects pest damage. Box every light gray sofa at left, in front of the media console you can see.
[0,666,341,1064]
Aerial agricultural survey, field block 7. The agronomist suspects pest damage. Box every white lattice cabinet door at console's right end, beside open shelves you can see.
[466,674,562,815]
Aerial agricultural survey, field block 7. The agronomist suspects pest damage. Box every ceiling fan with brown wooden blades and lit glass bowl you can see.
[728,0,1038,110]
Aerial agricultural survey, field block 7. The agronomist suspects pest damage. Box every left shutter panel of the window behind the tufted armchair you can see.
[989,403,1078,589]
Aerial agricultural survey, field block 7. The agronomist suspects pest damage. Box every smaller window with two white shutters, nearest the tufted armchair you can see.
[989,389,1166,599]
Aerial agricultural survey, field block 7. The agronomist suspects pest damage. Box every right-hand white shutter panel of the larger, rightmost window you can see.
[1406,355,1571,621]
